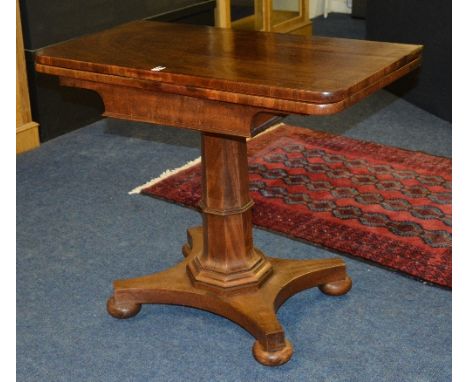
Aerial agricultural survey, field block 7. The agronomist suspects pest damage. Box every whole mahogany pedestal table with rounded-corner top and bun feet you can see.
[36,21,422,365]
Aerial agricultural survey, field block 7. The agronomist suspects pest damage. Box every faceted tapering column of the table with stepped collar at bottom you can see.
[188,133,271,291]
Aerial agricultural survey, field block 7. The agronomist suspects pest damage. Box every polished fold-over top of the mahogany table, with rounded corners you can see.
[36,21,422,111]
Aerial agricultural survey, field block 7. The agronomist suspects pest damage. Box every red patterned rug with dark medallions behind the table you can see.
[133,125,452,287]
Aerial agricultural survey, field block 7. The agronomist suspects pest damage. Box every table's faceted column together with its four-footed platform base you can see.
[107,133,352,366]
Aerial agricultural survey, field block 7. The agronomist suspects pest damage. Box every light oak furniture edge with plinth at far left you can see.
[16,1,39,154]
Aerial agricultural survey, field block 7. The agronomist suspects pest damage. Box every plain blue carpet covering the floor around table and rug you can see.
[17,91,451,382]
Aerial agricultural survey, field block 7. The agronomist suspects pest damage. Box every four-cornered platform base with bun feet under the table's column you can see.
[107,227,352,366]
